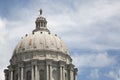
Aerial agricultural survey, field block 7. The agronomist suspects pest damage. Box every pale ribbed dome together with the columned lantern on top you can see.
[13,9,69,56]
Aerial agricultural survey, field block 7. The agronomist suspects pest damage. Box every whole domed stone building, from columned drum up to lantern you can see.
[4,10,78,80]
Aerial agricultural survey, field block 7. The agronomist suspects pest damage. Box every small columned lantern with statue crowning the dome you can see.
[33,9,49,32]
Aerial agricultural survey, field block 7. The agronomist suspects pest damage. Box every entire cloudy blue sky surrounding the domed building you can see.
[0,0,120,80]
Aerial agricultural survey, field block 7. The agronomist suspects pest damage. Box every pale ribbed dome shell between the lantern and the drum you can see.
[14,31,69,54]
